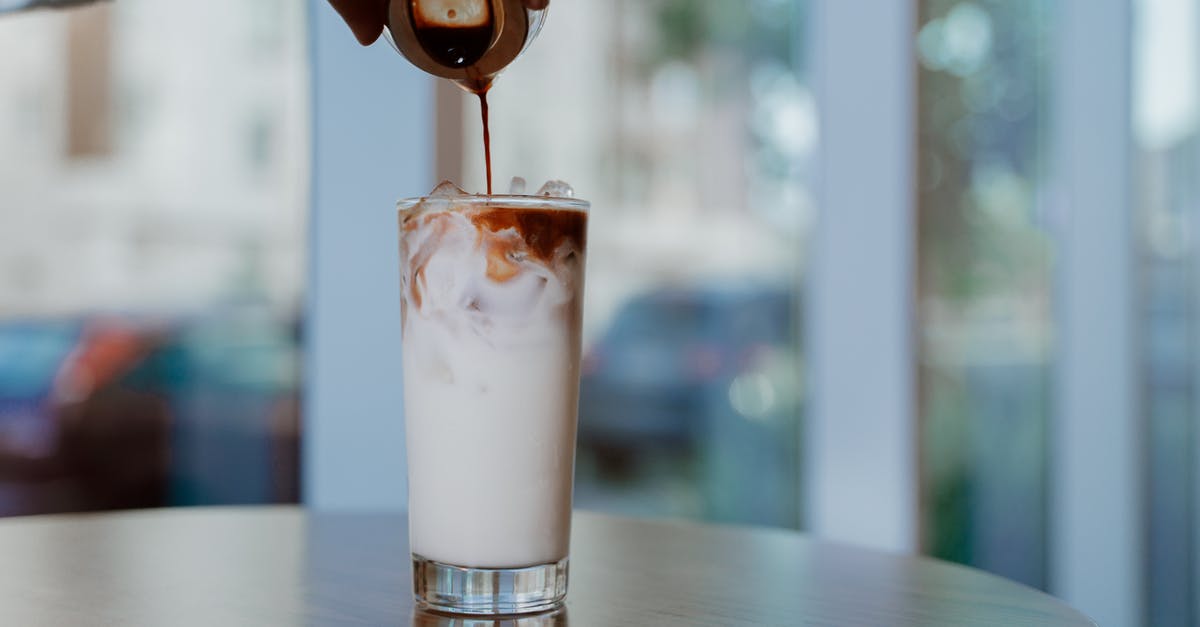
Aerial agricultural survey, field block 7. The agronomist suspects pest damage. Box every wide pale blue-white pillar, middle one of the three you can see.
[805,0,917,551]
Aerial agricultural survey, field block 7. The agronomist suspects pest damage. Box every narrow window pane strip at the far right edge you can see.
[1133,0,1200,626]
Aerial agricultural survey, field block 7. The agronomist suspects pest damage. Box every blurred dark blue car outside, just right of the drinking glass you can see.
[580,285,800,525]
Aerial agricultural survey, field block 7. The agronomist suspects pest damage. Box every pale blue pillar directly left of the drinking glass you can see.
[304,0,433,509]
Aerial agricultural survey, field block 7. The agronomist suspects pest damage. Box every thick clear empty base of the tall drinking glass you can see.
[413,554,568,615]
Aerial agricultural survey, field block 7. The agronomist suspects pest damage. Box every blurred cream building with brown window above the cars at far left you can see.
[0,0,308,317]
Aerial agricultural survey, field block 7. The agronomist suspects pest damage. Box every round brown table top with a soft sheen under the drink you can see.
[0,507,1092,627]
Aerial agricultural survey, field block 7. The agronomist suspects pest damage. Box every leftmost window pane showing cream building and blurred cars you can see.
[0,0,308,515]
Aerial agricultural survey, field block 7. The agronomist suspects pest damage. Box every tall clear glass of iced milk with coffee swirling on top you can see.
[400,195,588,614]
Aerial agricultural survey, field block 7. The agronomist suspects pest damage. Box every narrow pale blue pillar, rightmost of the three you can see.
[1050,0,1144,626]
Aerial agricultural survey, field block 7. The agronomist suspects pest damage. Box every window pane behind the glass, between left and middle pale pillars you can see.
[454,0,816,526]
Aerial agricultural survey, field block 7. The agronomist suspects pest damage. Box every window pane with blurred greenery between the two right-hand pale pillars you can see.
[916,0,1054,589]
